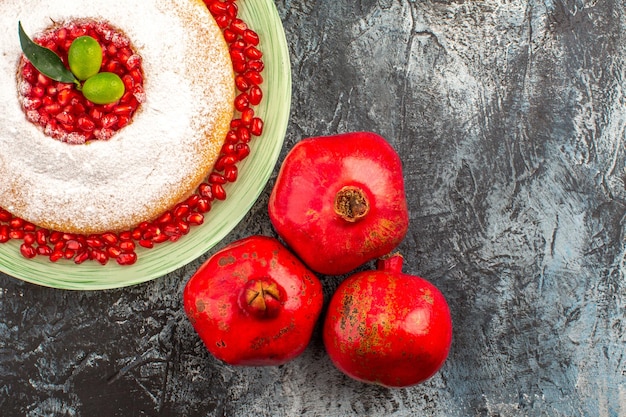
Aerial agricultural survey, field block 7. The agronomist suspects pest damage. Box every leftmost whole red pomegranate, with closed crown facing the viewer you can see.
[183,236,323,366]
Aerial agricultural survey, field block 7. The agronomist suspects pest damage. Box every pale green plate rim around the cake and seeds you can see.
[0,0,291,290]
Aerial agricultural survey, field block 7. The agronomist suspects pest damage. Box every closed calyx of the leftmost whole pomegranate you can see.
[241,277,284,318]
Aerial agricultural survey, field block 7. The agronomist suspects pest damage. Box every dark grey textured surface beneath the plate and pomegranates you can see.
[0,0,626,417]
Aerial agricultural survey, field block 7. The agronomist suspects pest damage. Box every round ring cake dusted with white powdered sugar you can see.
[0,0,235,234]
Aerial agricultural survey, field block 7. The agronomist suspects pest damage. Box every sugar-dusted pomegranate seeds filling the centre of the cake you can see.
[19,21,145,144]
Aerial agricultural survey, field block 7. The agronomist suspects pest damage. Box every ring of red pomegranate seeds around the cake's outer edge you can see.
[0,0,264,265]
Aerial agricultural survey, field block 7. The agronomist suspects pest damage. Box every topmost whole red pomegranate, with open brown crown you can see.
[268,132,409,275]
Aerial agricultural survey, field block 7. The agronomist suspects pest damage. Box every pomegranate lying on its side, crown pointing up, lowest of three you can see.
[323,254,452,388]
